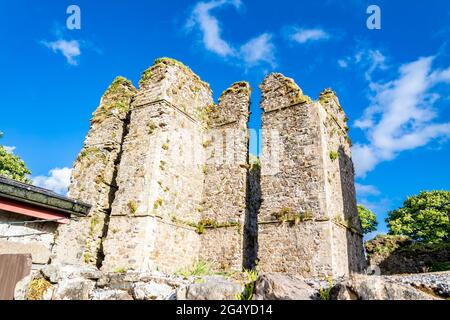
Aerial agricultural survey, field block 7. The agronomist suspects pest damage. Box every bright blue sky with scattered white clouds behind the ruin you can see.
[0,0,450,232]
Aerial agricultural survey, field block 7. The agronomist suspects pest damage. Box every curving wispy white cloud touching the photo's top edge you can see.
[188,0,241,57]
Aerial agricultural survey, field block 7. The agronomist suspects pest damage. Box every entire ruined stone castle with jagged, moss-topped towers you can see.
[52,58,365,276]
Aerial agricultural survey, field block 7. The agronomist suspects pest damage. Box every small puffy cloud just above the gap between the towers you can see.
[240,33,276,67]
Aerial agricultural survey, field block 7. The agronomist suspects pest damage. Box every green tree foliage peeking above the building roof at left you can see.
[0,131,31,183]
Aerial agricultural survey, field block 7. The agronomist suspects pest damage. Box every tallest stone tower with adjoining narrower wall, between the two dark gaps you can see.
[102,59,250,272]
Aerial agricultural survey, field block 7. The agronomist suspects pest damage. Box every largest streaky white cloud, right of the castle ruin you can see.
[353,56,450,177]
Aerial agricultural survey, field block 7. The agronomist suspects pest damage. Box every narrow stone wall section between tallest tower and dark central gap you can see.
[198,82,251,270]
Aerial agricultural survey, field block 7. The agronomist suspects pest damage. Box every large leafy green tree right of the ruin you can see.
[386,191,450,243]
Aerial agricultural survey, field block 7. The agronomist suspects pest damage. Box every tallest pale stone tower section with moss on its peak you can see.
[103,59,212,272]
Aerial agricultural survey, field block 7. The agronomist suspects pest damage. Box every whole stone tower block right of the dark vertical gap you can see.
[258,74,364,276]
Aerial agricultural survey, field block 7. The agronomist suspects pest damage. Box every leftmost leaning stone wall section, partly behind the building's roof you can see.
[53,77,136,265]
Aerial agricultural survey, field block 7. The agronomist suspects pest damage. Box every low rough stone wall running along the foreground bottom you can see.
[15,265,450,300]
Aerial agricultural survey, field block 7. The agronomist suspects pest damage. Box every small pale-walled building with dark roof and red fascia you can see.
[0,177,91,269]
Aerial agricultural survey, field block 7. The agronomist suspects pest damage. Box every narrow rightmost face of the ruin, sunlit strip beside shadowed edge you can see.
[319,89,365,274]
